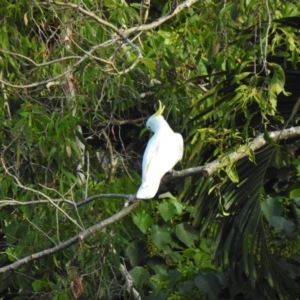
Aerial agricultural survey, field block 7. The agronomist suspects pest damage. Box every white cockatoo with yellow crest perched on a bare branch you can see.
[136,101,183,199]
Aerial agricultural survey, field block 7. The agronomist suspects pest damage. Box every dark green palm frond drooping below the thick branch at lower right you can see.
[188,146,300,299]
